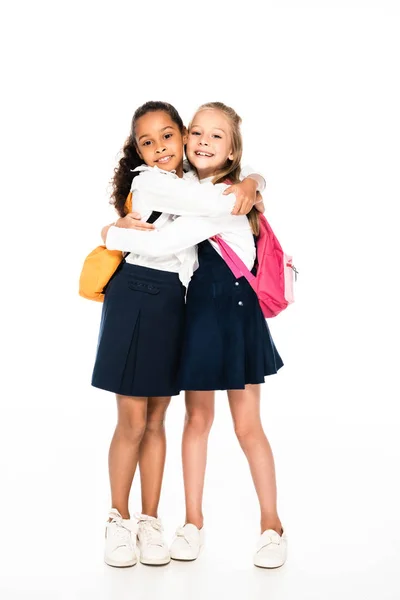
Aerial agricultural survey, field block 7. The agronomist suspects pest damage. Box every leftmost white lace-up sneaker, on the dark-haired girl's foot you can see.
[104,508,137,567]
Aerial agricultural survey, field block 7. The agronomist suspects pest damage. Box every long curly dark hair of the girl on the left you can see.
[110,101,184,217]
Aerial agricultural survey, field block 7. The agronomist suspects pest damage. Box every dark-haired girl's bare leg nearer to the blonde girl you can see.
[139,397,171,517]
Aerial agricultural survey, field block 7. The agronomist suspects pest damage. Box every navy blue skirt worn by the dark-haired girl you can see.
[92,261,185,396]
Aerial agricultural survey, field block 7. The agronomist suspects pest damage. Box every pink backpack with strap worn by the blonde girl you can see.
[211,214,298,318]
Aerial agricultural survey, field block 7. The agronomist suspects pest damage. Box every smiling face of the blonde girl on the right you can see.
[186,108,233,179]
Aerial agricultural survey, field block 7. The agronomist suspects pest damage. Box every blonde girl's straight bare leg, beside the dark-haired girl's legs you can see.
[182,391,214,529]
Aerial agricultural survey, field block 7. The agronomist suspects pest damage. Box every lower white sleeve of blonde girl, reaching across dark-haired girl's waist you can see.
[106,216,231,258]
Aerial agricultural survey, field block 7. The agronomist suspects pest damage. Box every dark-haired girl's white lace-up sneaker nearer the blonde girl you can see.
[135,514,171,565]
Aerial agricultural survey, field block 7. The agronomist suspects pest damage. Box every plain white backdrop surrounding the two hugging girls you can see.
[0,0,400,600]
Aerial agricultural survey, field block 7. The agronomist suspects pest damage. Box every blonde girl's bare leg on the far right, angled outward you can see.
[228,385,282,534]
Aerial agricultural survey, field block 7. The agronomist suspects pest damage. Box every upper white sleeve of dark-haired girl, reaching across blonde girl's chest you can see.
[132,171,236,217]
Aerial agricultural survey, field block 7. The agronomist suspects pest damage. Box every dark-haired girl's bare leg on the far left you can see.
[108,395,147,519]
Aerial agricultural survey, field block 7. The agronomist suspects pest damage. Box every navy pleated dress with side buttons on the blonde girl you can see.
[179,241,283,390]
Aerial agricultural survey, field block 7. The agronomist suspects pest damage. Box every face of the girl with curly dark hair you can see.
[135,110,187,177]
